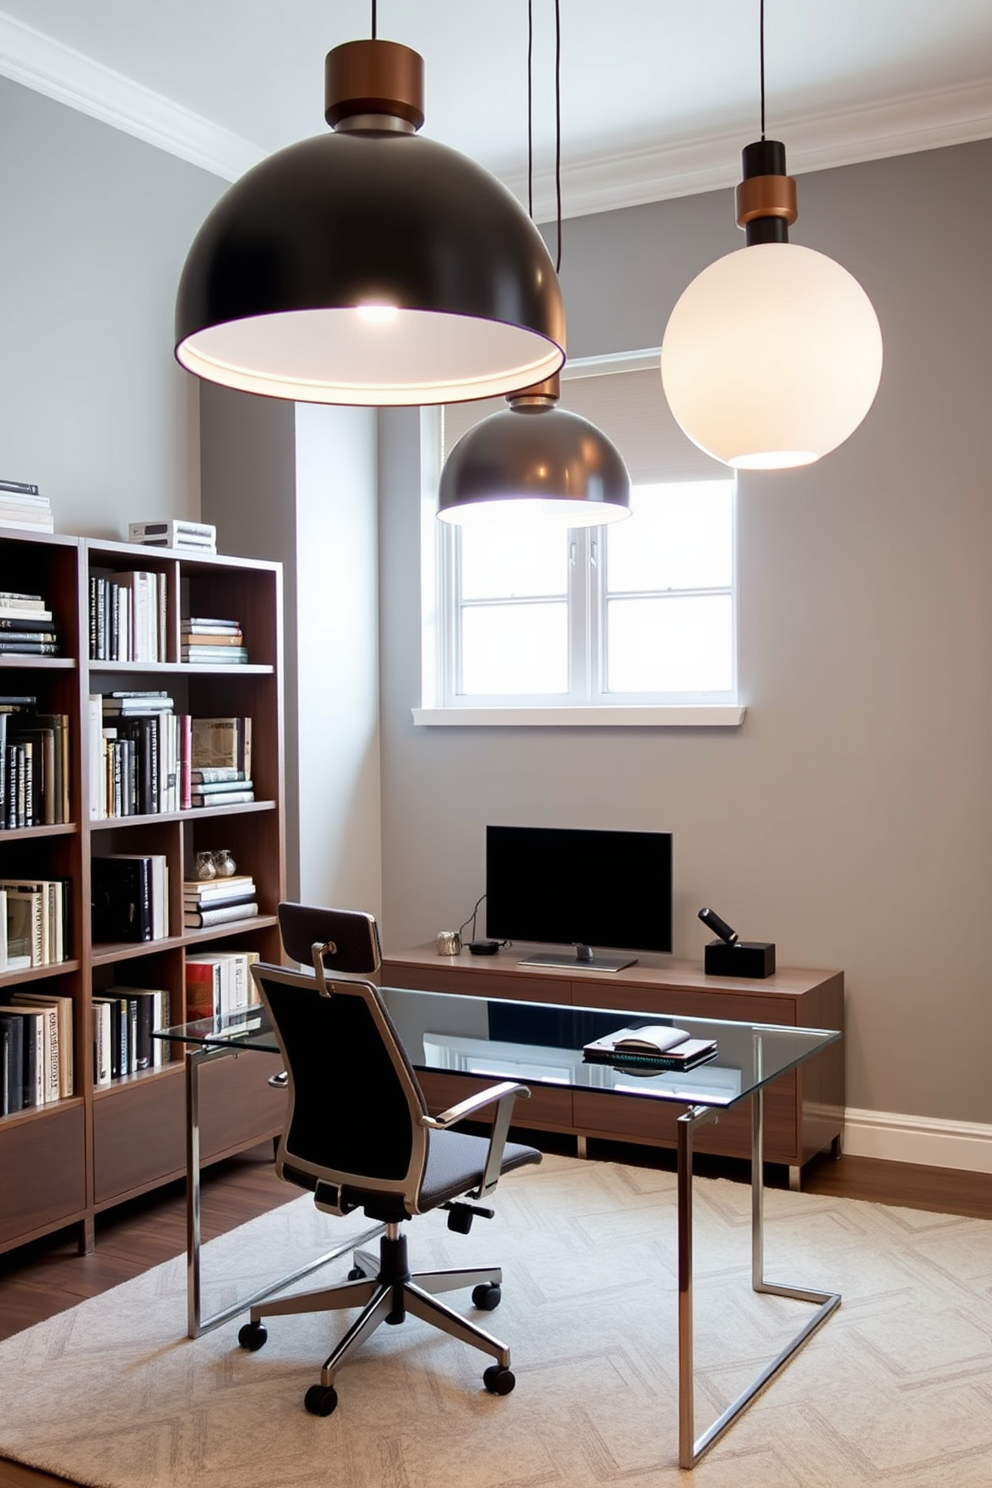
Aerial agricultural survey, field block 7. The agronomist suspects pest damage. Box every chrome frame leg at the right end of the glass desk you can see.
[677,1086,840,1467]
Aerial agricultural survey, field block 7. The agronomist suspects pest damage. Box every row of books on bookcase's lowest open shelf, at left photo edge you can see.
[0,990,76,1116]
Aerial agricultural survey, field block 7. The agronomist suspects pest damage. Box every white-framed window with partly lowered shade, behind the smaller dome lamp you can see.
[415,351,742,723]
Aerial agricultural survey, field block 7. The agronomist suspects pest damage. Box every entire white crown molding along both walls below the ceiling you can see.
[0,12,992,211]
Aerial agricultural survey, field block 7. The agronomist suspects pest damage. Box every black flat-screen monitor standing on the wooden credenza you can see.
[486,826,672,972]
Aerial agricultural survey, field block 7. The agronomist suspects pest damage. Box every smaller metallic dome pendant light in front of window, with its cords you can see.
[437,0,631,528]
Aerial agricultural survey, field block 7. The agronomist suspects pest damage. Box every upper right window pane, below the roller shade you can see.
[607,481,733,594]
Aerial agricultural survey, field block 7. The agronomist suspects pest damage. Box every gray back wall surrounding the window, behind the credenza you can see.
[381,141,992,1123]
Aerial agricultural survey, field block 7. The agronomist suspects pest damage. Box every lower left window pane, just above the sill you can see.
[460,604,568,696]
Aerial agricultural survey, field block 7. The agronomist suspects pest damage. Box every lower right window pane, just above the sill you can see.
[607,594,733,692]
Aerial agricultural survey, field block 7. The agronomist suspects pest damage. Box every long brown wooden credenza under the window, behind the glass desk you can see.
[379,945,845,1184]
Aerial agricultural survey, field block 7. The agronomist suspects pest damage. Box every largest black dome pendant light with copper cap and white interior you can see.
[175,4,565,406]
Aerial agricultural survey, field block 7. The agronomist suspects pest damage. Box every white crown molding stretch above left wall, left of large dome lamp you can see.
[0,12,265,180]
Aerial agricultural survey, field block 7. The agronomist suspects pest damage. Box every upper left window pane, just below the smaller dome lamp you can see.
[461,521,568,600]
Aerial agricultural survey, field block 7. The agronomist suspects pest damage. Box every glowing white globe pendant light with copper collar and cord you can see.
[662,0,882,470]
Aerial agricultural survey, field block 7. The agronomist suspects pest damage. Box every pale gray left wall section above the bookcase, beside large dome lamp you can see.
[0,79,223,539]
